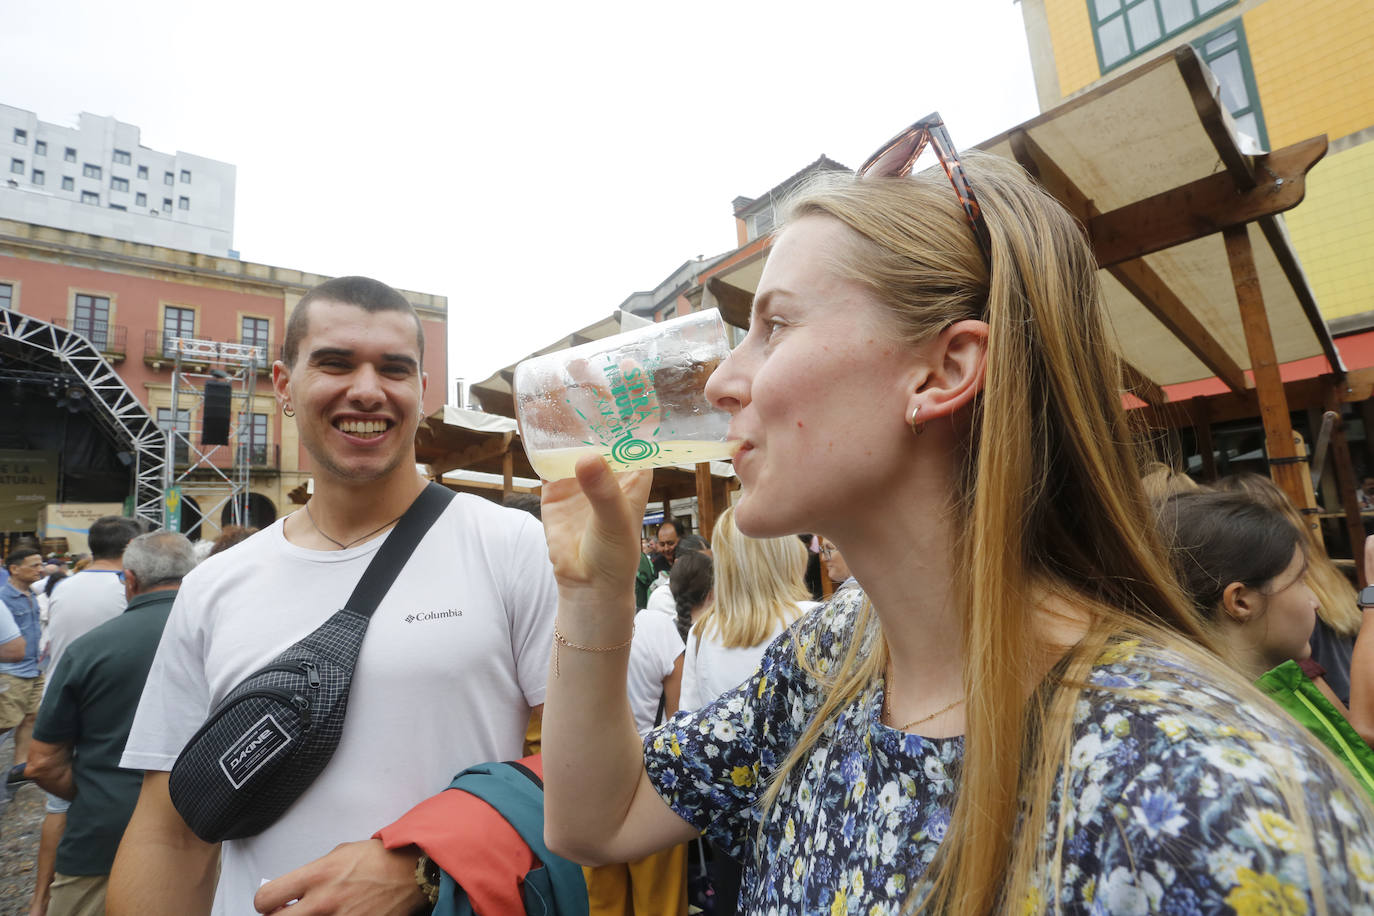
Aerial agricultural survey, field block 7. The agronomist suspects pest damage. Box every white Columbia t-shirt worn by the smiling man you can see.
[121,494,556,916]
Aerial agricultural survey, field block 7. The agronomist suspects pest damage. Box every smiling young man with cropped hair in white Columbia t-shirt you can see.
[109,277,556,916]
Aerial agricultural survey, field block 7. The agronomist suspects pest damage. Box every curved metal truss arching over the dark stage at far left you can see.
[0,309,170,526]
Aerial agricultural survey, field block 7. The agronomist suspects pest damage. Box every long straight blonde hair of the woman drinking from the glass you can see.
[764,154,1260,913]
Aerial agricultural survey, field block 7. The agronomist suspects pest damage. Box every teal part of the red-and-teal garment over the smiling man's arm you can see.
[434,761,587,916]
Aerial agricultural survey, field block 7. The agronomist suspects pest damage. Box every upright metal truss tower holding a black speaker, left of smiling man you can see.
[162,338,267,525]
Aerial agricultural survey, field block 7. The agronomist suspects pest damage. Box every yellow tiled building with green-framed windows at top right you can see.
[1021,0,1374,332]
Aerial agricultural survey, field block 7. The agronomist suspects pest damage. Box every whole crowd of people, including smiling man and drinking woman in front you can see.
[0,119,1374,916]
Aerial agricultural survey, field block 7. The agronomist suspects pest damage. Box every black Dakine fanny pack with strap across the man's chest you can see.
[169,483,453,843]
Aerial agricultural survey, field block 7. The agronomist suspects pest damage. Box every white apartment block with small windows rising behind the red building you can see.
[0,104,238,258]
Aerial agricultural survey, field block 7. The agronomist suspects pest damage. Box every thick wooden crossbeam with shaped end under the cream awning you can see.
[1088,135,1326,266]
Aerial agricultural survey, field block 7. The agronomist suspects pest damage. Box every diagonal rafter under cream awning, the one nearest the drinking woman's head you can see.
[1009,130,1248,391]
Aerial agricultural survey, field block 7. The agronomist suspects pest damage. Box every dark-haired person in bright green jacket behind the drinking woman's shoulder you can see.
[1156,490,1374,798]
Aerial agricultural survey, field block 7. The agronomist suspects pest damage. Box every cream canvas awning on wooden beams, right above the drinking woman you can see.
[978,45,1340,391]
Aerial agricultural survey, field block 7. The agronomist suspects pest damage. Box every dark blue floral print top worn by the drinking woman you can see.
[644,589,1374,916]
